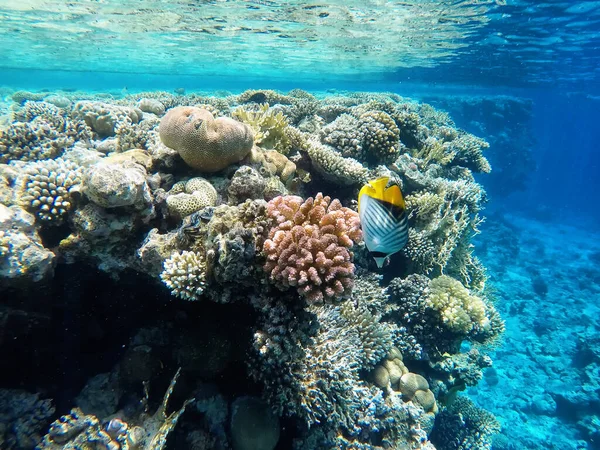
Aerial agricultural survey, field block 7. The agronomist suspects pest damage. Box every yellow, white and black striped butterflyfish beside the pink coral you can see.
[358,177,408,268]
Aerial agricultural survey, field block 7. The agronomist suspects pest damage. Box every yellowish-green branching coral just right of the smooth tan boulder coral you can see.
[232,103,291,155]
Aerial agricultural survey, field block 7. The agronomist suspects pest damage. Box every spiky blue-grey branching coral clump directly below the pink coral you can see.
[250,301,390,433]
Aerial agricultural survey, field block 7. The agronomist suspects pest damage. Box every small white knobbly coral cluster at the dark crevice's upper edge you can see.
[160,251,206,300]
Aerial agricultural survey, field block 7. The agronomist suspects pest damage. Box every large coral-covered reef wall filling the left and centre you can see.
[0,88,510,450]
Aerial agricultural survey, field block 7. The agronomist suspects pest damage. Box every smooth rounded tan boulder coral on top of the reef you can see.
[159,106,254,172]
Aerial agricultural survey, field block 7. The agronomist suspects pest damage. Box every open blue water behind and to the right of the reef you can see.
[0,1,600,450]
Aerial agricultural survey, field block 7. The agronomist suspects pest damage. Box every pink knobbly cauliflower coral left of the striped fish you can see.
[263,193,362,303]
